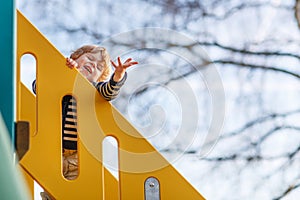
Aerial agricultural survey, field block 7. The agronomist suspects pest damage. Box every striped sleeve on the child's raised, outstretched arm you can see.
[94,72,127,101]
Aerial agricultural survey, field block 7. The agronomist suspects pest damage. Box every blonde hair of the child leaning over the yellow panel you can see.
[70,45,112,82]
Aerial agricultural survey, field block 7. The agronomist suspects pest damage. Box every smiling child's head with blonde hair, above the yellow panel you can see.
[70,45,111,82]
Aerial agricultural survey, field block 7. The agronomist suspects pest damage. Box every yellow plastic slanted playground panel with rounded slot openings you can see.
[17,12,204,200]
